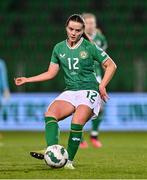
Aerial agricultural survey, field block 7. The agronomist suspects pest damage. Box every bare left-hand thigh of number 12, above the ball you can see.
[45,100,75,121]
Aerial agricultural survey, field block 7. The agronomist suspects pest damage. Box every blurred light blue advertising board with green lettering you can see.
[0,93,147,131]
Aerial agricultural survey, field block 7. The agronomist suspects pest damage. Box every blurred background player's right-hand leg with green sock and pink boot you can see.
[90,110,103,148]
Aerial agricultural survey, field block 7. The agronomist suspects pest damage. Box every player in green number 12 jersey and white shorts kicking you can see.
[15,14,116,169]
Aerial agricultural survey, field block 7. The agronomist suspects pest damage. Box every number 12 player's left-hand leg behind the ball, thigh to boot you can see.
[30,100,75,159]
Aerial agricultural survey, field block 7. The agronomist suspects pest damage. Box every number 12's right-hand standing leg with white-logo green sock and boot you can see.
[65,105,92,169]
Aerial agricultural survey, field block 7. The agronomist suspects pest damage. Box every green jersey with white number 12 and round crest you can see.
[51,38,108,91]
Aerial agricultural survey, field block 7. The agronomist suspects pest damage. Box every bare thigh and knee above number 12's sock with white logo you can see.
[72,105,93,125]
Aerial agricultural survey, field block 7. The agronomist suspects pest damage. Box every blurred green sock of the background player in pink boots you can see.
[92,112,102,134]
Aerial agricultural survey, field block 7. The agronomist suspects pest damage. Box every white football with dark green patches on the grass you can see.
[44,144,68,168]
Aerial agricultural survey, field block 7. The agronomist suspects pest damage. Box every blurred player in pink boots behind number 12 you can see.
[80,13,107,148]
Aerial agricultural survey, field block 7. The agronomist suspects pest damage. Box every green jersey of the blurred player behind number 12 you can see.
[91,31,107,78]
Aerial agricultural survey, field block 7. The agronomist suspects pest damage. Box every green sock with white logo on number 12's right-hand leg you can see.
[67,124,83,161]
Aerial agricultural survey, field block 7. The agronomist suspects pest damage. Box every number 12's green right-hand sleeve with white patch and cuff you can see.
[92,44,109,63]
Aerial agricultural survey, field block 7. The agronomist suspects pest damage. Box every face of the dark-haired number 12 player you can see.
[66,21,84,43]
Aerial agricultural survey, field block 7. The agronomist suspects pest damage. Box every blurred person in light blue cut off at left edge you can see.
[0,59,10,145]
